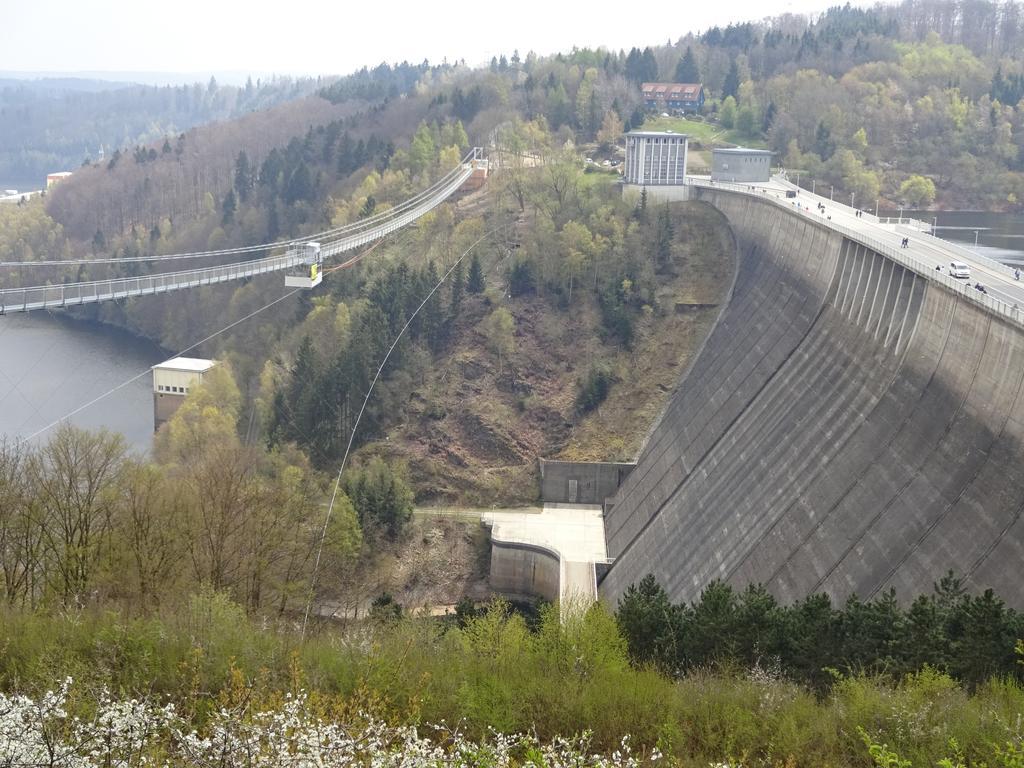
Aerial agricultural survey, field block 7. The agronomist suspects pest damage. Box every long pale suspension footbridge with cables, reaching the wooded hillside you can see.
[0,147,485,314]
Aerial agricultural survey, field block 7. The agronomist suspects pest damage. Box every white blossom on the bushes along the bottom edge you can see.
[0,679,662,768]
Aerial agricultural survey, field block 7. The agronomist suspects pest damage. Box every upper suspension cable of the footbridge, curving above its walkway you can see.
[0,147,482,267]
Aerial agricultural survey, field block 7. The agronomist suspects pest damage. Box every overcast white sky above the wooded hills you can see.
[0,0,864,81]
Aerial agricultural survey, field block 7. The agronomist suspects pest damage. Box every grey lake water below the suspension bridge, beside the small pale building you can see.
[0,312,168,453]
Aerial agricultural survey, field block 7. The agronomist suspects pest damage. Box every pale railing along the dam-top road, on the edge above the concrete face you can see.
[689,179,1024,327]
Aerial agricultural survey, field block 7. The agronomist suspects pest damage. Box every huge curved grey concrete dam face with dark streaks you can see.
[600,189,1024,608]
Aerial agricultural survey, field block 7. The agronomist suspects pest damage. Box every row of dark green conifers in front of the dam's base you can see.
[616,572,1024,691]
